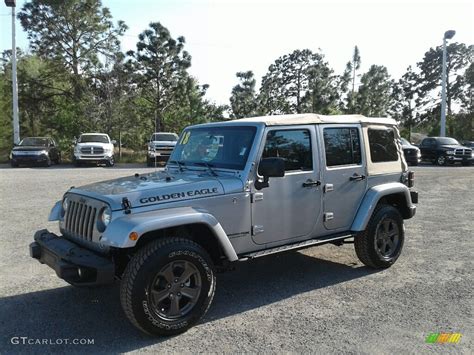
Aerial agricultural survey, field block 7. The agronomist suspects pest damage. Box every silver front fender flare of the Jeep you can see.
[100,207,238,261]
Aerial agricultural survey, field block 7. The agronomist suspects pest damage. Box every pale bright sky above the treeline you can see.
[0,0,474,103]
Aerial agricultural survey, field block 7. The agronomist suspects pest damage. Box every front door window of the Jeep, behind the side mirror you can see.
[262,129,313,171]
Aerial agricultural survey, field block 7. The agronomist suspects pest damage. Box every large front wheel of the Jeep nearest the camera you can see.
[120,237,216,335]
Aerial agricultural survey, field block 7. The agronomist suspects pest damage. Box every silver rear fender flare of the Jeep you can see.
[351,182,415,232]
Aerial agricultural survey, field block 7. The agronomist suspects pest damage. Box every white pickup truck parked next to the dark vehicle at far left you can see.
[72,133,116,166]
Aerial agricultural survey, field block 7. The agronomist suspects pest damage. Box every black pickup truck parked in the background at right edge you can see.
[420,137,474,166]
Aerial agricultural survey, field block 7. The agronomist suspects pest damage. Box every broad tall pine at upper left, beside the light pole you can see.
[18,0,127,99]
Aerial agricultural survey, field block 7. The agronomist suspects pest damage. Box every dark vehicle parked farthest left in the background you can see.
[10,137,61,167]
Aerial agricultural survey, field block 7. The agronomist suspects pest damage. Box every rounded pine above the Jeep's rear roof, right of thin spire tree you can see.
[356,65,391,117]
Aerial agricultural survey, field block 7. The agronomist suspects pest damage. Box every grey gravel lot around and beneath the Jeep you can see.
[0,165,474,354]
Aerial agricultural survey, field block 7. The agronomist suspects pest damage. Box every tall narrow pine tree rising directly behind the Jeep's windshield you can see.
[127,22,191,130]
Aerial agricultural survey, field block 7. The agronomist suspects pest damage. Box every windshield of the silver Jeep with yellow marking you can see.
[170,127,256,170]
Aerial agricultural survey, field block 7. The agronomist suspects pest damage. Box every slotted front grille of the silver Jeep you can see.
[64,201,98,241]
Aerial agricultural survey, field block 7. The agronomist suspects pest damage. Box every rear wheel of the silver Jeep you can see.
[354,205,405,269]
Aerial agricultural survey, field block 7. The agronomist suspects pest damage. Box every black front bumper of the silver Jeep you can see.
[30,229,115,286]
